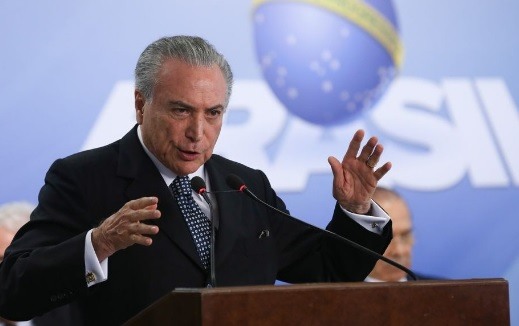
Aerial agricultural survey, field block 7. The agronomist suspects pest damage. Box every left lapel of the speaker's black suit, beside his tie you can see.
[118,127,203,269]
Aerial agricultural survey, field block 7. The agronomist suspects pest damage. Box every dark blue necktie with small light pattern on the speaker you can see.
[169,176,211,269]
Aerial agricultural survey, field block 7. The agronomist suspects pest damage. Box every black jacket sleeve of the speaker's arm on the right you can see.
[251,172,392,283]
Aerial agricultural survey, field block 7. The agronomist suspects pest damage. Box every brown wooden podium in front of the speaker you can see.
[125,279,510,326]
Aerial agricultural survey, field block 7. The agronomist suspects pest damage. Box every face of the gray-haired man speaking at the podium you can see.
[135,59,227,175]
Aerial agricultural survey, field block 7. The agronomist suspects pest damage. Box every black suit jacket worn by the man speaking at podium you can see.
[0,128,391,325]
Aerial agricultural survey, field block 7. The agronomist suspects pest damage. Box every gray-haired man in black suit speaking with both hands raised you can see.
[0,36,391,325]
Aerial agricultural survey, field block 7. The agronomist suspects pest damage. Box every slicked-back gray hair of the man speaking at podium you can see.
[135,35,233,106]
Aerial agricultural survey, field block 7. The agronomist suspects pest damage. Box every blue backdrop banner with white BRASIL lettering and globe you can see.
[0,0,519,323]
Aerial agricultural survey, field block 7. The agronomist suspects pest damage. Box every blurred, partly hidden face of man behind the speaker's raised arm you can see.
[370,199,414,281]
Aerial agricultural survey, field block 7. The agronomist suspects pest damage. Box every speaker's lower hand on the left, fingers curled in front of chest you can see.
[92,197,160,262]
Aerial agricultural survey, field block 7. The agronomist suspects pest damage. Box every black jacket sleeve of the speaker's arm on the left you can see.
[0,160,93,320]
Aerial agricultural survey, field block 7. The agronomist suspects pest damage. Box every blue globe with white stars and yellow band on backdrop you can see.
[253,0,403,126]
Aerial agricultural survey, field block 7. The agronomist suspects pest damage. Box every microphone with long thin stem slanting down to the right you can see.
[225,174,416,281]
